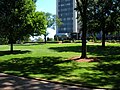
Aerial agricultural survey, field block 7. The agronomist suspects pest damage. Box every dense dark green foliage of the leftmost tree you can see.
[0,0,35,41]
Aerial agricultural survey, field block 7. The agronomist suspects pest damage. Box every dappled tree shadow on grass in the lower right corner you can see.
[73,56,120,90]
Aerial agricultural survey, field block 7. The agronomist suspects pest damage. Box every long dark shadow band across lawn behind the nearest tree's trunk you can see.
[49,45,120,56]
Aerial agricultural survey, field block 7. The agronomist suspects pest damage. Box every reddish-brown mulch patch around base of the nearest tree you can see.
[69,56,100,62]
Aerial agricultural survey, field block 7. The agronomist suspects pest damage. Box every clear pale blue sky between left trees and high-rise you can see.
[36,0,56,14]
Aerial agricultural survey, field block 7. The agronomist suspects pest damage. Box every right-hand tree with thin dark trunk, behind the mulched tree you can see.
[93,0,120,47]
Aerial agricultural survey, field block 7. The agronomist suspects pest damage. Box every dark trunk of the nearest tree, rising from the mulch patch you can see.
[75,0,88,58]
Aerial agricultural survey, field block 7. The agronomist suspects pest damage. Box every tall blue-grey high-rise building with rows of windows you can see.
[56,0,78,34]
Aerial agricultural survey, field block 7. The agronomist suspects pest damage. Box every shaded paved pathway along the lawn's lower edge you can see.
[0,73,103,90]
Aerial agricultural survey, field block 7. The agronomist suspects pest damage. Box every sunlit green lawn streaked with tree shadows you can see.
[0,43,120,89]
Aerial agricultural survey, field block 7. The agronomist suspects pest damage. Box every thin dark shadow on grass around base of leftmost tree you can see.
[0,50,31,56]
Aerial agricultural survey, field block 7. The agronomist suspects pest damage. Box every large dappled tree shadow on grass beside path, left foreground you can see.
[0,57,96,87]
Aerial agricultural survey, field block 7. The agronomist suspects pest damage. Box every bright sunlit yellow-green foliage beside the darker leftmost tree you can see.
[26,12,47,36]
